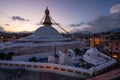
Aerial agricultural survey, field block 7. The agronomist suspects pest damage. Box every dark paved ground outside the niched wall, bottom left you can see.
[0,69,82,80]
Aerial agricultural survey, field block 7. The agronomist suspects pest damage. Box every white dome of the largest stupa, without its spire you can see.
[33,25,62,37]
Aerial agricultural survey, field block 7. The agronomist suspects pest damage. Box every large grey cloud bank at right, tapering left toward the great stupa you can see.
[70,5,120,32]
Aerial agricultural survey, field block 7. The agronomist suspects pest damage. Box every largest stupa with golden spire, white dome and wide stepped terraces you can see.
[4,7,83,54]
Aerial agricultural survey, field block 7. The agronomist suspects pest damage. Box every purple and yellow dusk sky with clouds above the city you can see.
[0,0,120,32]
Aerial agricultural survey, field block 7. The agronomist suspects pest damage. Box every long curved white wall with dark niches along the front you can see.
[0,61,93,79]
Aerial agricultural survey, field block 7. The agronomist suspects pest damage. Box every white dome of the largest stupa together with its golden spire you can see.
[33,7,62,37]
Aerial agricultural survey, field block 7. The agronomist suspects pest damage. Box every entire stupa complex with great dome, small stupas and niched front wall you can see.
[0,8,117,79]
